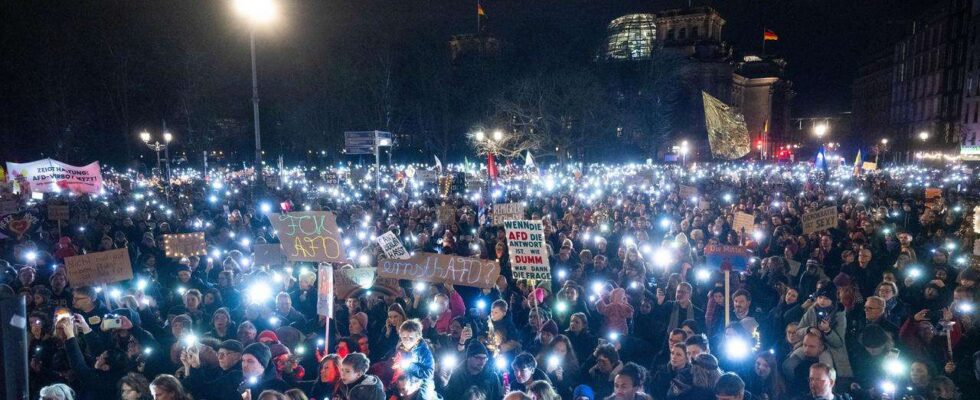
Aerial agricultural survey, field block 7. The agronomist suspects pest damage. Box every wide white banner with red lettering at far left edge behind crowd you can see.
[7,158,102,193]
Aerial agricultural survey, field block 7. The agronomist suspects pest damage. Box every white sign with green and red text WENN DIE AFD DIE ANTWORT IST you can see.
[504,220,551,281]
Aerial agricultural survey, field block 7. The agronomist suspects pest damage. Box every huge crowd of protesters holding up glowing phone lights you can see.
[0,163,980,400]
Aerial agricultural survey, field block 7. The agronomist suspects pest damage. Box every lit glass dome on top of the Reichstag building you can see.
[605,14,657,60]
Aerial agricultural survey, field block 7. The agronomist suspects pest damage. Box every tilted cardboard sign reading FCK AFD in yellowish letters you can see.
[269,211,346,262]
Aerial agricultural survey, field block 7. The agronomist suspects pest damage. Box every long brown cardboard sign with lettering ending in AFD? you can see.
[378,253,500,289]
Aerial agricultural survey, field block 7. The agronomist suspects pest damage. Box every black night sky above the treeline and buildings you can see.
[0,0,927,160]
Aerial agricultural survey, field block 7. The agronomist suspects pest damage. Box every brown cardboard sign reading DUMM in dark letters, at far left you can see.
[65,248,133,288]
